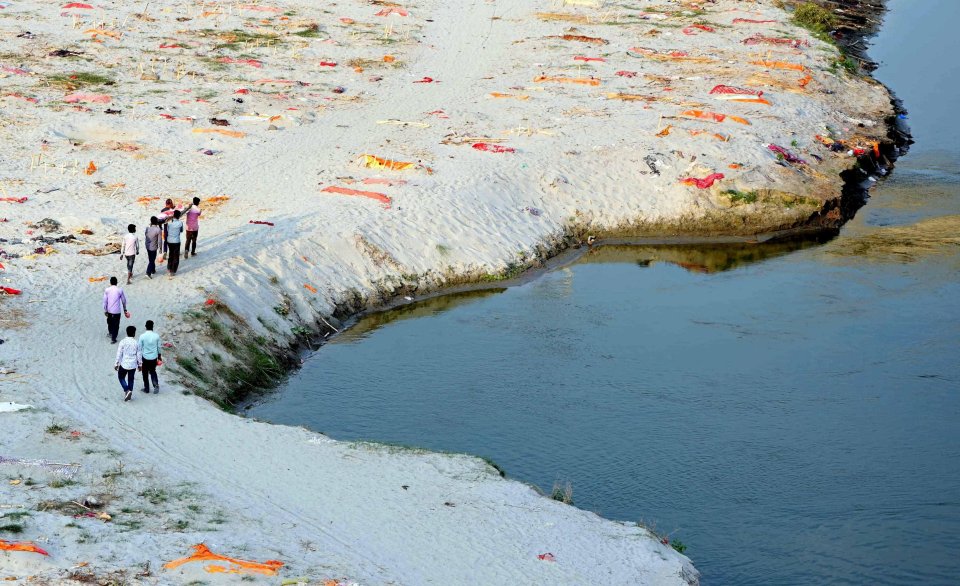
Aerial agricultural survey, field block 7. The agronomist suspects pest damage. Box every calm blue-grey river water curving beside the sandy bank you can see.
[249,0,960,585]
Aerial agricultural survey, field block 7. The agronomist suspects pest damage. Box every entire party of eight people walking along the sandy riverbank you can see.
[103,197,202,401]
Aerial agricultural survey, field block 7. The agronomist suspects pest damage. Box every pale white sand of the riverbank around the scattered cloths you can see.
[0,0,890,584]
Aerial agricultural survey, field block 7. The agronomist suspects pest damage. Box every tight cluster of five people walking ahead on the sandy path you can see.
[120,197,203,285]
